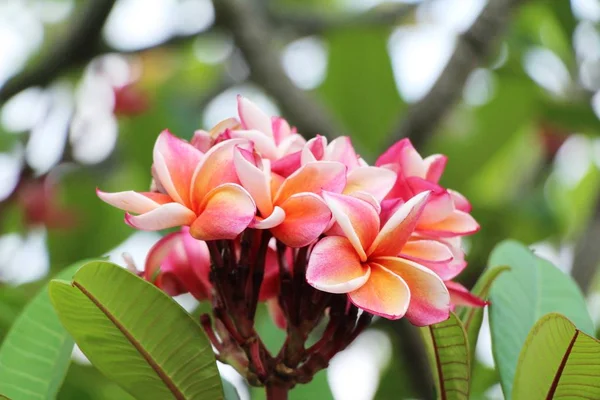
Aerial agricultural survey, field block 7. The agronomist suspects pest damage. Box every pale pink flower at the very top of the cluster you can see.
[230,96,306,161]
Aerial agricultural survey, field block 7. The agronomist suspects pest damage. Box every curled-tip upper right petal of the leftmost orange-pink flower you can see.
[191,139,249,211]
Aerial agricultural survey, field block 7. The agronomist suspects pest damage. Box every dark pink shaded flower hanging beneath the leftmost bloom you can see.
[143,227,212,300]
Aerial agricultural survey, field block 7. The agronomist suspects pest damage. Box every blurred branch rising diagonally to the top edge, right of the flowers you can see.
[392,0,524,147]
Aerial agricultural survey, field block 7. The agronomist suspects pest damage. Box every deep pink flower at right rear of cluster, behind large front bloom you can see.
[375,139,479,237]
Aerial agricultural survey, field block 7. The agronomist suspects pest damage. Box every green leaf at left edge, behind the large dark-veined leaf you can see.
[0,260,89,400]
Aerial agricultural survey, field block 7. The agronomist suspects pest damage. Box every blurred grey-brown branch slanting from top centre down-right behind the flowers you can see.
[214,0,341,138]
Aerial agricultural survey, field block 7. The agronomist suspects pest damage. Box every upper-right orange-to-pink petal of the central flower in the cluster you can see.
[274,161,346,204]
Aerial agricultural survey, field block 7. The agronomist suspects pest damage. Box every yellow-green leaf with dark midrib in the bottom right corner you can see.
[512,313,600,399]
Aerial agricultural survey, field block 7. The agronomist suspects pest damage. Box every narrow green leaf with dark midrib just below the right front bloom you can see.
[421,313,471,400]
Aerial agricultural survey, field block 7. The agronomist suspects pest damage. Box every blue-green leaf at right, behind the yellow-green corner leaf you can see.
[489,241,594,399]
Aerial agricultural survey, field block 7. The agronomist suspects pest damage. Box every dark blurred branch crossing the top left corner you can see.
[0,0,115,102]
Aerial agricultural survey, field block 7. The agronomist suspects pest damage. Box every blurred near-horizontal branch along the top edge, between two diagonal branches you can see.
[271,4,417,35]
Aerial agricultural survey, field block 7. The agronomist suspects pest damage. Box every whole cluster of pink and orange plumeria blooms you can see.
[98,97,485,326]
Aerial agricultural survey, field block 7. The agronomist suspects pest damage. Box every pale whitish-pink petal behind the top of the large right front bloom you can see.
[344,167,396,201]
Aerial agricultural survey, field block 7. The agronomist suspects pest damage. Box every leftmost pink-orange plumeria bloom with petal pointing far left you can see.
[98,131,256,240]
